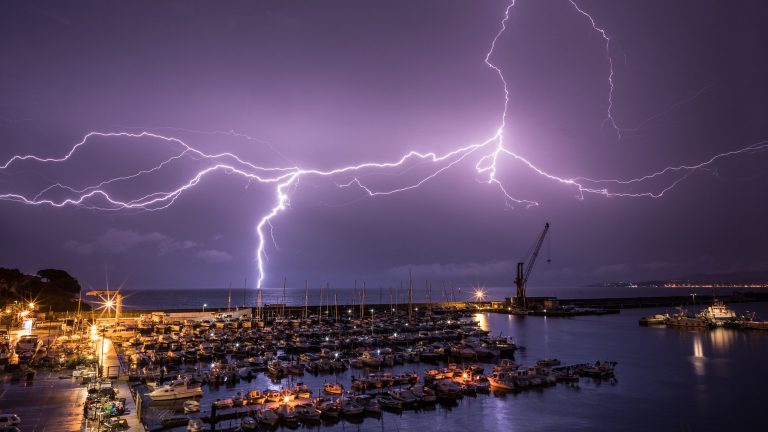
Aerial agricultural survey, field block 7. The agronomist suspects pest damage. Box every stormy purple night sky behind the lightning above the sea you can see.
[0,0,768,288]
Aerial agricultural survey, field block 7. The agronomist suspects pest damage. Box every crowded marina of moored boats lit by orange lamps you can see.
[4,305,615,430]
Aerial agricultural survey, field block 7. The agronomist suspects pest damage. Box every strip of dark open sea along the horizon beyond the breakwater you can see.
[117,286,768,310]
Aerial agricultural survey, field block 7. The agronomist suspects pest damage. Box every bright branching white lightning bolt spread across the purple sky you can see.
[0,0,768,289]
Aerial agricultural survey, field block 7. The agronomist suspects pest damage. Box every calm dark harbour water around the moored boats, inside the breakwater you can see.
[152,303,768,432]
